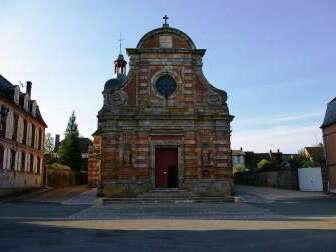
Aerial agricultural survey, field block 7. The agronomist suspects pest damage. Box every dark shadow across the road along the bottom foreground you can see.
[0,221,336,252]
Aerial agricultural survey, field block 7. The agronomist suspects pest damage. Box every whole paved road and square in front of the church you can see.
[0,187,336,252]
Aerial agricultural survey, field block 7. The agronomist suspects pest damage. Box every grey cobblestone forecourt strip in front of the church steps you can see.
[70,203,282,219]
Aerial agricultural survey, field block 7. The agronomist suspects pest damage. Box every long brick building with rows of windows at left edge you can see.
[0,75,47,189]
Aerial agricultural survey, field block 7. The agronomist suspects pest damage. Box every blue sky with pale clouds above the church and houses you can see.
[0,0,336,153]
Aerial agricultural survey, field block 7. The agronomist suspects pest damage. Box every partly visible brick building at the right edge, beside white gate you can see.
[321,97,336,193]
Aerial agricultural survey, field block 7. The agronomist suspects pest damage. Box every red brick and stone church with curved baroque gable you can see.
[88,16,233,197]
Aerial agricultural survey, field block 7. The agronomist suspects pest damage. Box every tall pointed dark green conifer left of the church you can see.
[59,111,82,171]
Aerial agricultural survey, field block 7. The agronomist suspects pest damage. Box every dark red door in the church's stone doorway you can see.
[155,148,178,188]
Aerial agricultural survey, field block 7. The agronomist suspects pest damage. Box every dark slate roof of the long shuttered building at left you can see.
[0,74,47,127]
